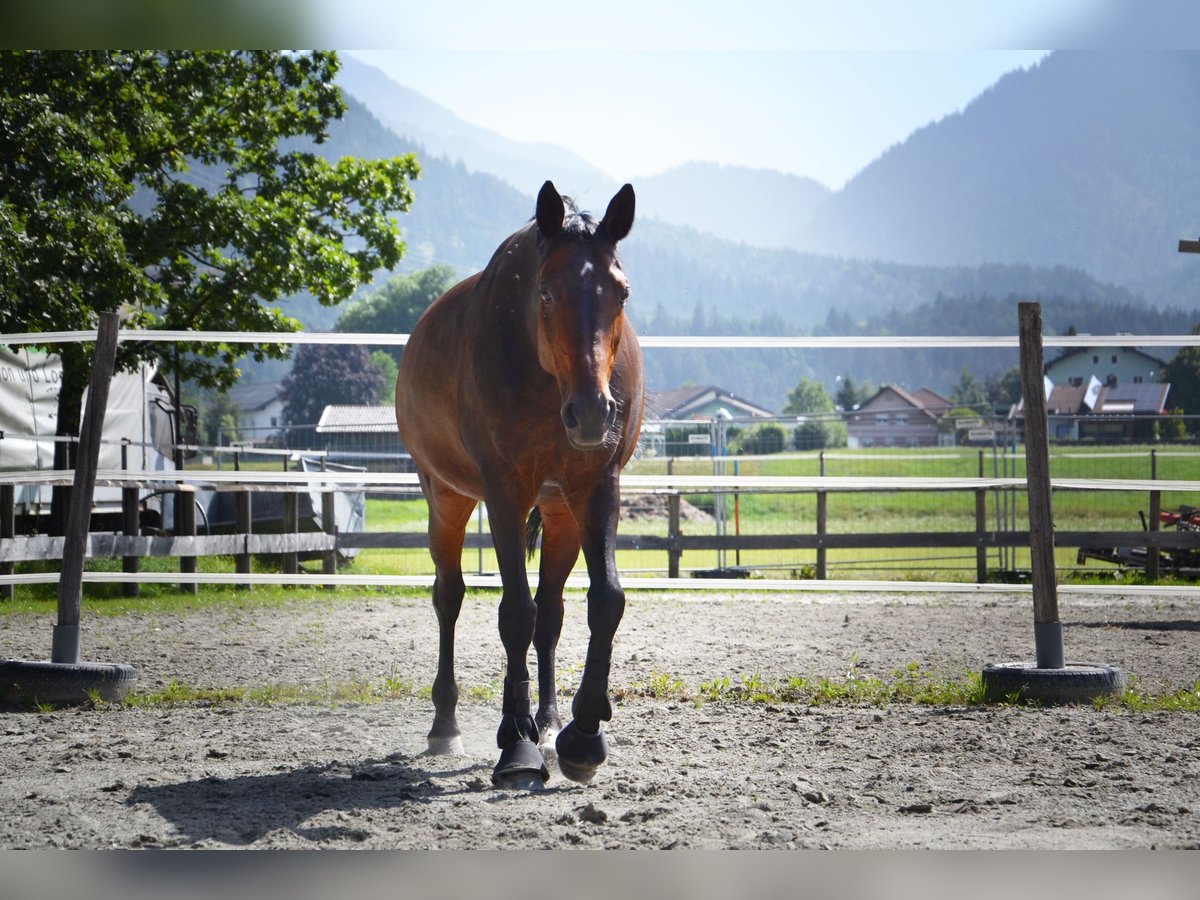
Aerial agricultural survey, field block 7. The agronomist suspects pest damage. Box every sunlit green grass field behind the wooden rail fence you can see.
[9,445,1200,596]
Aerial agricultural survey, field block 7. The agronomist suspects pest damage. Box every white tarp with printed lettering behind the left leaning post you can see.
[0,347,174,505]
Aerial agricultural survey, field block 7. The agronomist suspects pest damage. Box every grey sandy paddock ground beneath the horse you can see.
[0,593,1200,848]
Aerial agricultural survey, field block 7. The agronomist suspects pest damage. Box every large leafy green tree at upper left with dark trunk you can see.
[0,50,419,523]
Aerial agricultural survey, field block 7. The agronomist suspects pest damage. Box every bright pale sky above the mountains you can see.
[314,0,1104,188]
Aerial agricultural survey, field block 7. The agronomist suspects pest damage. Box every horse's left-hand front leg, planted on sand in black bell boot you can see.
[487,496,550,790]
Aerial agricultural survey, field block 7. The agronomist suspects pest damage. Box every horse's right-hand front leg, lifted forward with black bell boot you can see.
[554,470,625,784]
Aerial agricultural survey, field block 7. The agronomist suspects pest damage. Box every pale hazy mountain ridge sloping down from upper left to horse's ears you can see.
[337,53,620,194]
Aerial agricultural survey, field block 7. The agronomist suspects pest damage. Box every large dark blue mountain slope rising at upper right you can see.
[791,50,1200,300]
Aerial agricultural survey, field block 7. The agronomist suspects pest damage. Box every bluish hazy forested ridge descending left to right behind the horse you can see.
[285,54,1194,407]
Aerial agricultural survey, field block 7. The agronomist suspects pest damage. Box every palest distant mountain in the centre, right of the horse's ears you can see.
[636,162,830,247]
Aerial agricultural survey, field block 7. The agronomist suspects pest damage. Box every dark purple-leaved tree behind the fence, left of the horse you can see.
[280,344,383,425]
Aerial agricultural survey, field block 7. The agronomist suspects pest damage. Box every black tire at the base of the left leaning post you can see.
[0,660,138,707]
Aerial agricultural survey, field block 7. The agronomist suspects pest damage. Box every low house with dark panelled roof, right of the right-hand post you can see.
[1010,376,1171,443]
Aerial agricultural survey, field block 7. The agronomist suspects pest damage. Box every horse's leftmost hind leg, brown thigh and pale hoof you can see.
[421,476,475,756]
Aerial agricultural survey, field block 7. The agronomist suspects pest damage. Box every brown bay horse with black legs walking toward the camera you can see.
[396,181,646,787]
